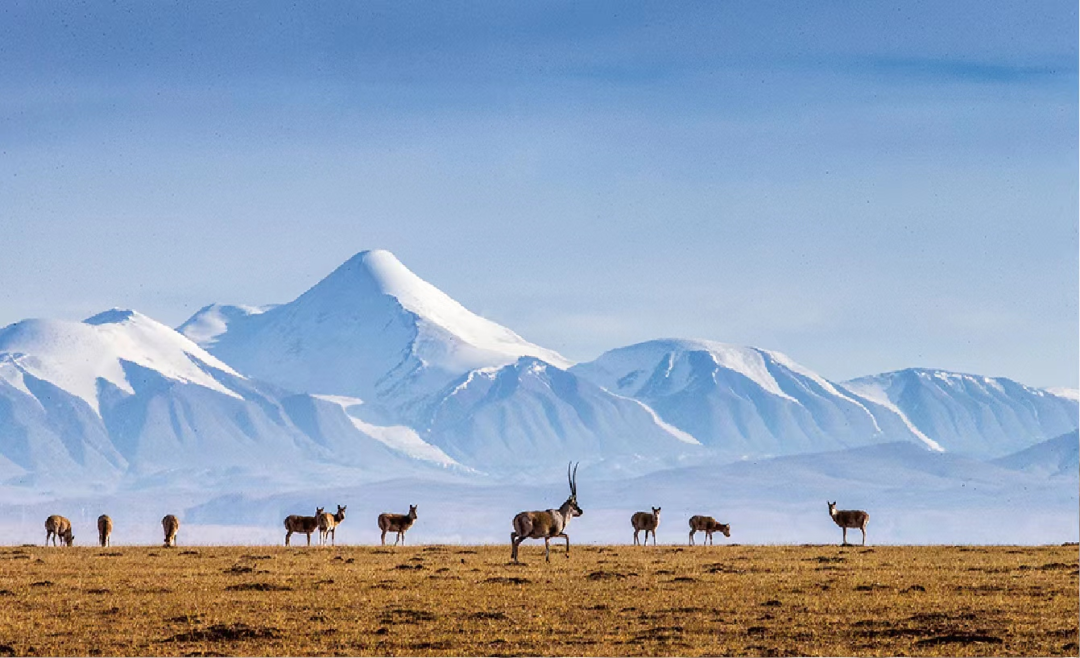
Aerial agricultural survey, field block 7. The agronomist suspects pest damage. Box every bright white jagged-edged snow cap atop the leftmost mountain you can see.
[0,309,239,412]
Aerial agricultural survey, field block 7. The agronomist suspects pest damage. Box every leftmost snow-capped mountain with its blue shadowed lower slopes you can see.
[0,309,460,485]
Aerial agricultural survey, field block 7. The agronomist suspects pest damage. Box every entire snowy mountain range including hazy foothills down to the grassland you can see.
[0,252,1080,541]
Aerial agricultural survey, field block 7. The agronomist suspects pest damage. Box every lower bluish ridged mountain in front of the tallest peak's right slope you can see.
[416,357,702,473]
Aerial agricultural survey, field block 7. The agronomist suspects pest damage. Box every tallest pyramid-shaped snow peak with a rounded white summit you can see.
[189,251,569,417]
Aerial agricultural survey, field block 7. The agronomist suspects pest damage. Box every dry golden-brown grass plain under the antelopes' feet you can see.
[0,542,1080,656]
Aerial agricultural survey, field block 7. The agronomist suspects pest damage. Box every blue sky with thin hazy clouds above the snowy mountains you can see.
[0,1,1080,387]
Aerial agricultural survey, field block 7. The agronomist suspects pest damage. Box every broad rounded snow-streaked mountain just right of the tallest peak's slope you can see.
[571,339,935,457]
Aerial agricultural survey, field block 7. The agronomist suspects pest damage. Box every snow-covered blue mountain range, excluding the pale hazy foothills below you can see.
[0,250,1078,486]
